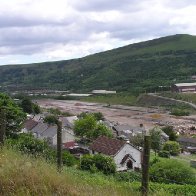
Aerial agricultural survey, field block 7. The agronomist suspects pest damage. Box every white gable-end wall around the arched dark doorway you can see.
[114,144,141,170]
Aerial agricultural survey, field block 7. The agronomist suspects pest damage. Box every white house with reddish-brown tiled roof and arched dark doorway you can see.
[89,136,142,171]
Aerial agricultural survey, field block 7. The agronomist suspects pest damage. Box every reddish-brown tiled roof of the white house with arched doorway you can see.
[90,136,126,155]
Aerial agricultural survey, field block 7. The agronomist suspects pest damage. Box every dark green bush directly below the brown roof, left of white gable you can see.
[80,154,116,174]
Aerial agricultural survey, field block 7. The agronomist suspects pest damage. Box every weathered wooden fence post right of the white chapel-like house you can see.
[142,135,150,196]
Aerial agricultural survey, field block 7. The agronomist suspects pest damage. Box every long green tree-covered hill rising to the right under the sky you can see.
[0,34,196,92]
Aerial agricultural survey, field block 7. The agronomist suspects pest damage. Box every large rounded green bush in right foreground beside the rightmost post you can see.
[150,159,196,184]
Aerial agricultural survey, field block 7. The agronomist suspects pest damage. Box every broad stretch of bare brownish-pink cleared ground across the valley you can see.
[37,99,196,132]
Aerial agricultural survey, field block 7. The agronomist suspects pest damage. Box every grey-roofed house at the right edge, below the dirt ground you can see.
[177,137,196,153]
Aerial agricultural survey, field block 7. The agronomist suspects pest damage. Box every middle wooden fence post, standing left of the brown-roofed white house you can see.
[57,120,62,172]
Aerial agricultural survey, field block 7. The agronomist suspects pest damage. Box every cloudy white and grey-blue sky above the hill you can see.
[0,0,196,65]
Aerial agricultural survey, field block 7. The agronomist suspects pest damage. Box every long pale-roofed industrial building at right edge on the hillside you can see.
[171,82,196,93]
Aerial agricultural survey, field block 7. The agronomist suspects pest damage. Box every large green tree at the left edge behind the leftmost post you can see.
[0,93,26,136]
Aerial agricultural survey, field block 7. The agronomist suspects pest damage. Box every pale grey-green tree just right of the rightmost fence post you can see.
[150,127,162,155]
